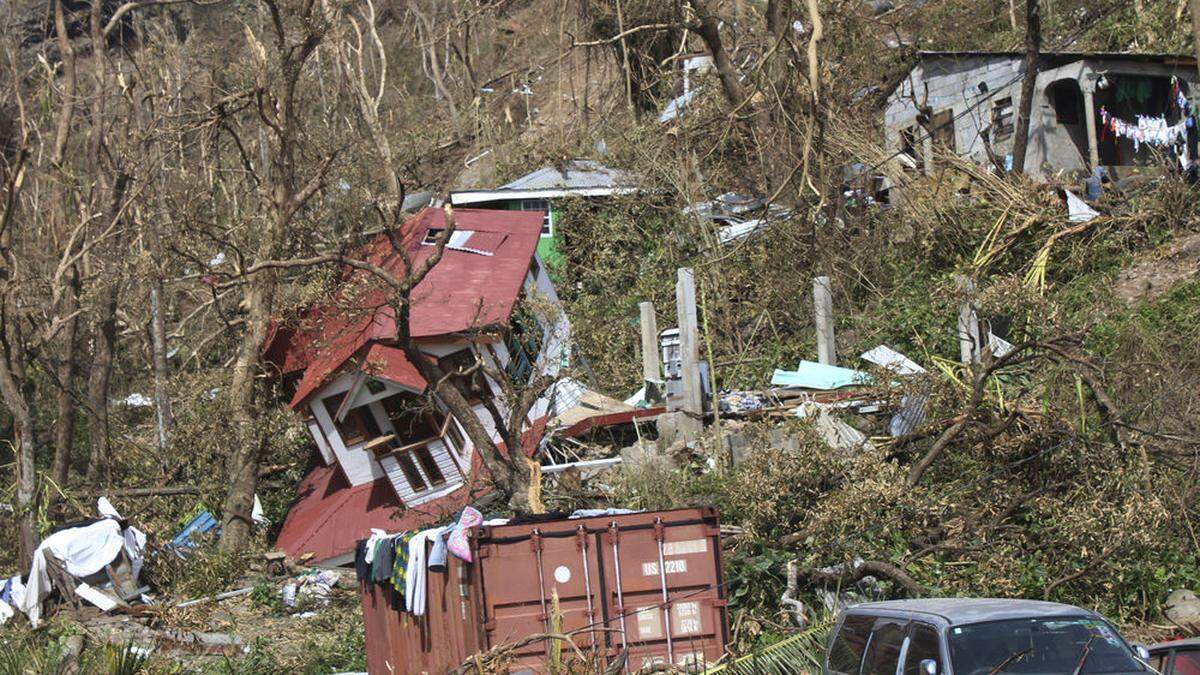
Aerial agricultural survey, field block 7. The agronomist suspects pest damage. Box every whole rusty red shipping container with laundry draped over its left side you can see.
[362,508,730,675]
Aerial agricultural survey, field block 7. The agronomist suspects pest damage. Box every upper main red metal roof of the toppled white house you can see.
[265,208,542,407]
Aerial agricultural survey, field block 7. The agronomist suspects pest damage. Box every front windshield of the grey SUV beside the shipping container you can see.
[949,617,1146,675]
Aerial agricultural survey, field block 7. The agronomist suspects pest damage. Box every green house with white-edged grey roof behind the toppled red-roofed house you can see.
[450,160,637,268]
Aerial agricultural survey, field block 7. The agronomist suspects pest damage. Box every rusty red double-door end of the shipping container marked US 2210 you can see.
[476,508,728,673]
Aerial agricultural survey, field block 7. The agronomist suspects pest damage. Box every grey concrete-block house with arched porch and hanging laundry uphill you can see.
[883,52,1196,179]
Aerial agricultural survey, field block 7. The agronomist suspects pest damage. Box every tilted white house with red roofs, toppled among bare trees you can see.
[266,208,575,565]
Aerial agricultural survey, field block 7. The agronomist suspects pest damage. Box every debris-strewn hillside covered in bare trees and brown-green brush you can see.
[0,0,1200,673]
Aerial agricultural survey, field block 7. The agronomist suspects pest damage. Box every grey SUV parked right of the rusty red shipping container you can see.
[823,598,1148,675]
